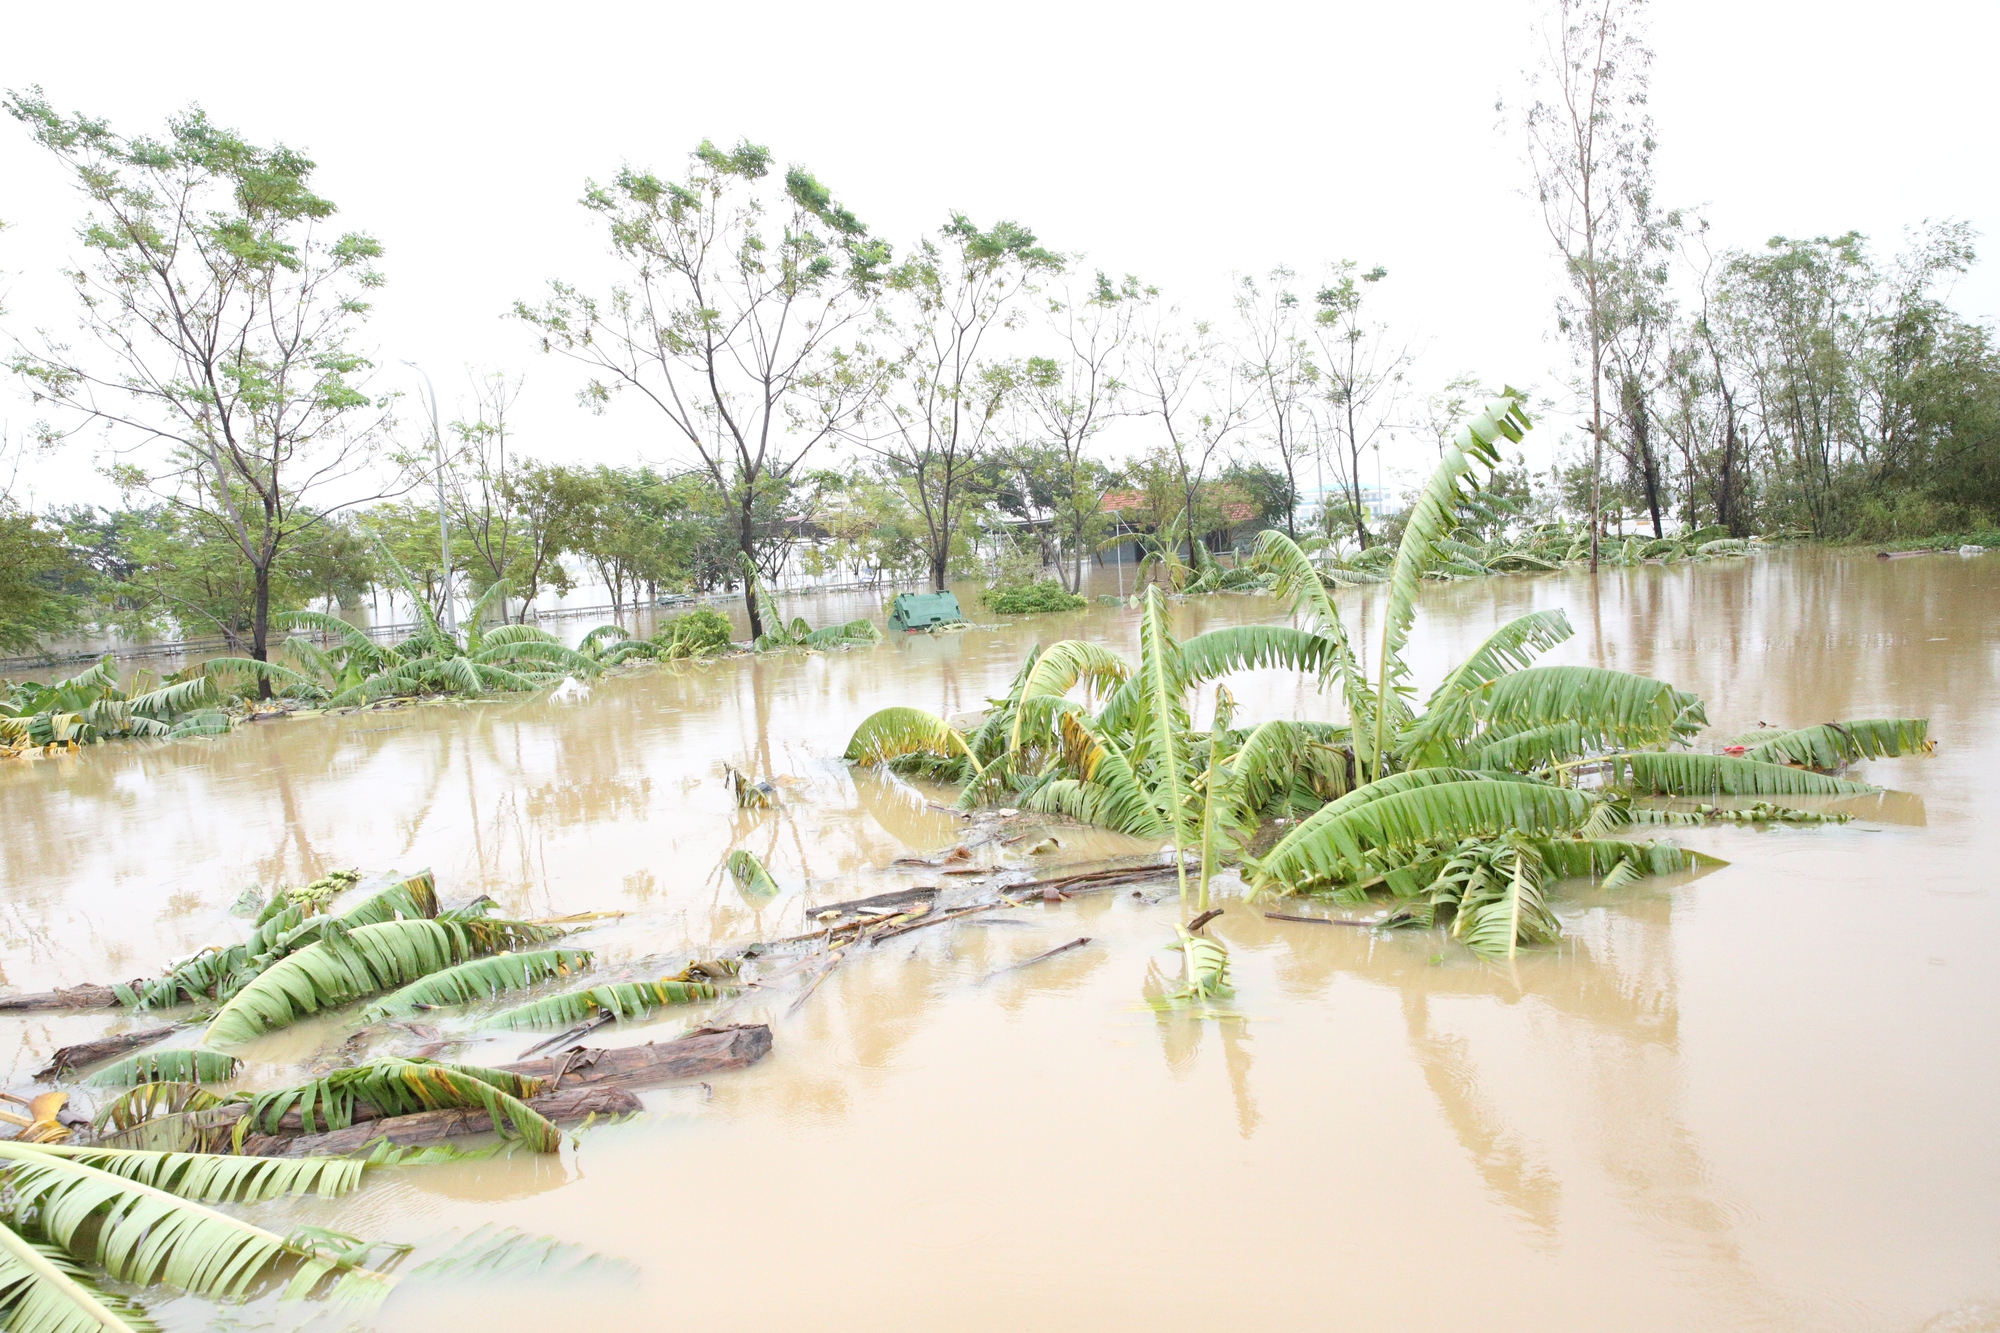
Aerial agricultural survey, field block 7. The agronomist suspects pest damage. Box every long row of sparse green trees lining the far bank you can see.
[0,29,2000,660]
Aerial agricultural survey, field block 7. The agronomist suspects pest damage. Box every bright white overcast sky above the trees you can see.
[0,0,2000,502]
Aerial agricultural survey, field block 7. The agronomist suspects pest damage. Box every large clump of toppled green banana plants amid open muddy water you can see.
[846,390,1930,955]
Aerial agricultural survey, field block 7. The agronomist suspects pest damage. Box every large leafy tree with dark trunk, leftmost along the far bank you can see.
[6,90,400,697]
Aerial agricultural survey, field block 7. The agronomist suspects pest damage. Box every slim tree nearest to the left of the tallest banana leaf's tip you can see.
[1312,260,1410,550]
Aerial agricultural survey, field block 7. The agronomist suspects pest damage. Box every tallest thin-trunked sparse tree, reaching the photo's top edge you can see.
[1522,0,1652,572]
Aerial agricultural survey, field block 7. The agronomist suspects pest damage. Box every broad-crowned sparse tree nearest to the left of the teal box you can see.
[514,140,890,636]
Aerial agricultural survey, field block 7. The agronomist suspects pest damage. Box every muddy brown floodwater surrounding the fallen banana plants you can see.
[0,550,2000,1333]
